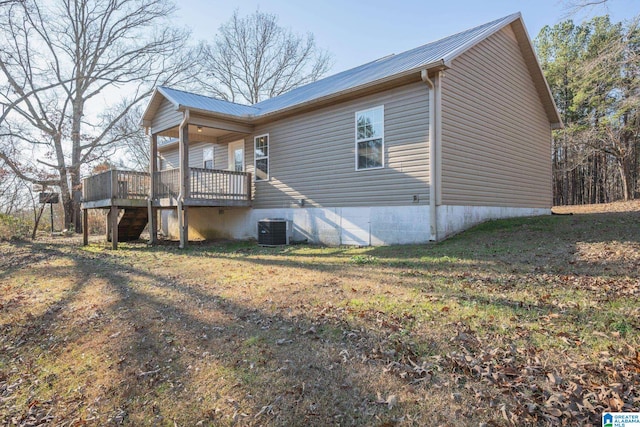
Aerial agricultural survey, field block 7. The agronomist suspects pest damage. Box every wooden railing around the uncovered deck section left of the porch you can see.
[82,169,151,202]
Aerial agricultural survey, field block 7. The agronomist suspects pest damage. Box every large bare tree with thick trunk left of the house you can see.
[0,0,195,231]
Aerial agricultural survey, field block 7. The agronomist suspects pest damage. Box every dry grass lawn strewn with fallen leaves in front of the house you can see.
[0,203,640,426]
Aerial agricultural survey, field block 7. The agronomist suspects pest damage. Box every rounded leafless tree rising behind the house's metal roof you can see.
[201,11,331,104]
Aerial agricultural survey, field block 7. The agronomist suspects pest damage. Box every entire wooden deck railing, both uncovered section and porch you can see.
[82,168,252,202]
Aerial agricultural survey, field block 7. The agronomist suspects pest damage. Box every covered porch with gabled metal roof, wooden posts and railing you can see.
[142,87,254,248]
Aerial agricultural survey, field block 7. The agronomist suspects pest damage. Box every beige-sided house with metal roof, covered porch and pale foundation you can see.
[84,13,562,249]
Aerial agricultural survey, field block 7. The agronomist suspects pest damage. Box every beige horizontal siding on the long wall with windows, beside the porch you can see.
[245,83,429,208]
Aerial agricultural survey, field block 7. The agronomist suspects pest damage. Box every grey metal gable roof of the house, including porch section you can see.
[143,12,562,126]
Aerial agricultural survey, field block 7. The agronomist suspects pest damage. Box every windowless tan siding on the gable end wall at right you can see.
[441,27,551,207]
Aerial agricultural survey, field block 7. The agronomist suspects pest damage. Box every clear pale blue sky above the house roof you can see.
[178,0,640,74]
